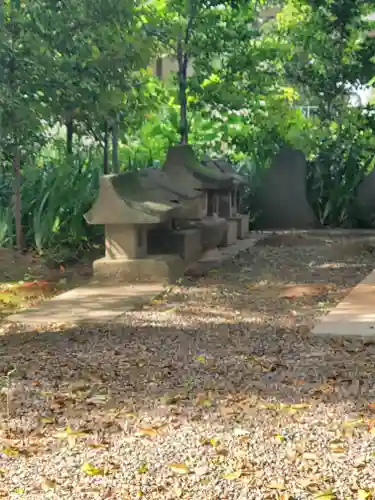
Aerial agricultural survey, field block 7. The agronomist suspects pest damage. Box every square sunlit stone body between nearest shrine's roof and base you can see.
[105,224,147,260]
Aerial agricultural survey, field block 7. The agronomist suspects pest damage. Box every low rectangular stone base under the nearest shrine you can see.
[93,255,184,284]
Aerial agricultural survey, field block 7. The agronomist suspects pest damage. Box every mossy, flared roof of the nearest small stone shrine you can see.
[85,168,199,224]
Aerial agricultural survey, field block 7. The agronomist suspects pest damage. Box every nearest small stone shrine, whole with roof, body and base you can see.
[85,169,200,283]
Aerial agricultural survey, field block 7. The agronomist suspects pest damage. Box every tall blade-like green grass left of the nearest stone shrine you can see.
[0,142,102,261]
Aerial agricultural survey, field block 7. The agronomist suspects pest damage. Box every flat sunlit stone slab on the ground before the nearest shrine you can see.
[7,283,165,326]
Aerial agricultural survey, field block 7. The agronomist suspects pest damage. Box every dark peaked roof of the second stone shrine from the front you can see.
[162,144,233,191]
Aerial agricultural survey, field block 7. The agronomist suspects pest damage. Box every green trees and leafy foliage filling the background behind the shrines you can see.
[0,0,375,259]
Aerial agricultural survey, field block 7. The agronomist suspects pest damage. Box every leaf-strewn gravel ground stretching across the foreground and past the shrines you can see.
[0,237,375,500]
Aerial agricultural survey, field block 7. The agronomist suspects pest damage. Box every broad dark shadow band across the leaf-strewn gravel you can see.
[0,313,375,426]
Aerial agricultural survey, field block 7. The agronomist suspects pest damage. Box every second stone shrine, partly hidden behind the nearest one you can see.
[162,145,233,260]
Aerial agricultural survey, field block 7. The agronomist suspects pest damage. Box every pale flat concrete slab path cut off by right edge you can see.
[312,270,375,337]
